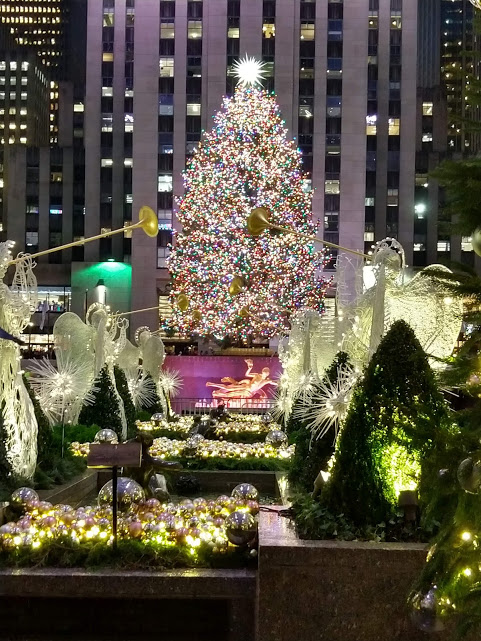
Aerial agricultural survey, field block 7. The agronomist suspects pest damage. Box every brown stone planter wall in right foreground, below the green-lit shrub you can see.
[256,512,449,641]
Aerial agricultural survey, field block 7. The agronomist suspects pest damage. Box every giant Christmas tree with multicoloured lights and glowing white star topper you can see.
[169,58,326,339]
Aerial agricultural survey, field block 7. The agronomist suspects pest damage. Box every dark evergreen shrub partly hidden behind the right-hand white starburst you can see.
[287,352,349,492]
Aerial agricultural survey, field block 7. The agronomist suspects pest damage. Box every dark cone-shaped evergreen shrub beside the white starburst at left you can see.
[79,367,122,439]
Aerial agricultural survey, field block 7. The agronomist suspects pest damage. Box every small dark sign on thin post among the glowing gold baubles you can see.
[87,441,142,550]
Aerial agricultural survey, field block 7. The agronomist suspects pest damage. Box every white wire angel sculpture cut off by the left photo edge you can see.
[0,241,38,479]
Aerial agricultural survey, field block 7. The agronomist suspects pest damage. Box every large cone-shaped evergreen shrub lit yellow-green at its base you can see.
[321,321,448,525]
